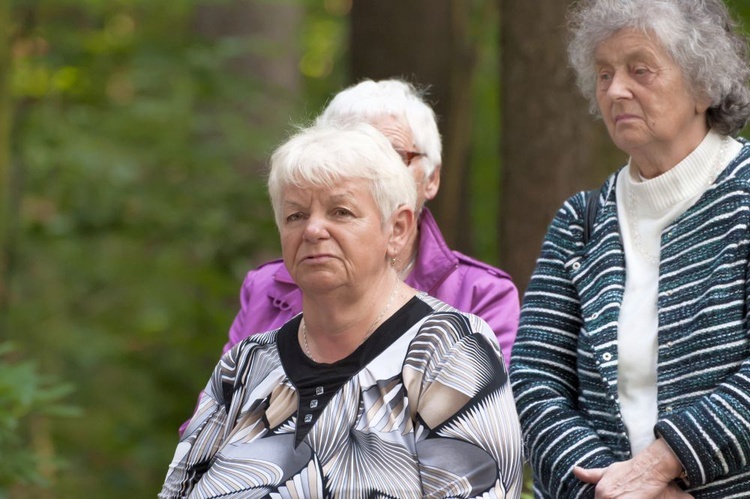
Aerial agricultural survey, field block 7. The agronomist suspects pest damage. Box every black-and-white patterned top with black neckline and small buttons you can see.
[159,294,523,499]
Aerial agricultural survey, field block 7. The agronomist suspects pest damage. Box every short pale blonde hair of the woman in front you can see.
[268,122,417,227]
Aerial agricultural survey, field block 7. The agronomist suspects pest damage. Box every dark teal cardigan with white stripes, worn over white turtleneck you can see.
[510,142,750,499]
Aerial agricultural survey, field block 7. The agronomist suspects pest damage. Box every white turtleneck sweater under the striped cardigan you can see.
[616,130,742,455]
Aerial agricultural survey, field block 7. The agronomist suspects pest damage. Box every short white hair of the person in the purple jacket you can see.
[317,79,442,177]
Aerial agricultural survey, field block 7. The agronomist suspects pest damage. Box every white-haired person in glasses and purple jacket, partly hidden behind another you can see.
[180,79,520,433]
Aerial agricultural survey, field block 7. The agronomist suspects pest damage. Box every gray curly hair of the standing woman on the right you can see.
[568,0,750,136]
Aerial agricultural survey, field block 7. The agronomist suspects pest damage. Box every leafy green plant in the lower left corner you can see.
[0,342,78,497]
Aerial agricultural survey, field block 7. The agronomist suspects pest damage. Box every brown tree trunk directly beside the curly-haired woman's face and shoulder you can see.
[499,0,624,292]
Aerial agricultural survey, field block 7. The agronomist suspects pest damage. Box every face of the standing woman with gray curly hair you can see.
[595,29,708,170]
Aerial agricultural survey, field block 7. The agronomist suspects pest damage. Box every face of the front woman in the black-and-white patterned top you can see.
[279,179,393,292]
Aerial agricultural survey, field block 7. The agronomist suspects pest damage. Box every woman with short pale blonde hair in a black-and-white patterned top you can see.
[159,124,523,499]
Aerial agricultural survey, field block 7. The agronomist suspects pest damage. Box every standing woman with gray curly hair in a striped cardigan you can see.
[511,0,750,499]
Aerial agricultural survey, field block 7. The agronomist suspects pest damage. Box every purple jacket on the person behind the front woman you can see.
[224,208,519,365]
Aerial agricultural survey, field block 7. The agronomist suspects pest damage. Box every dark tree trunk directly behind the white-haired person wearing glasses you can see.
[350,0,476,253]
